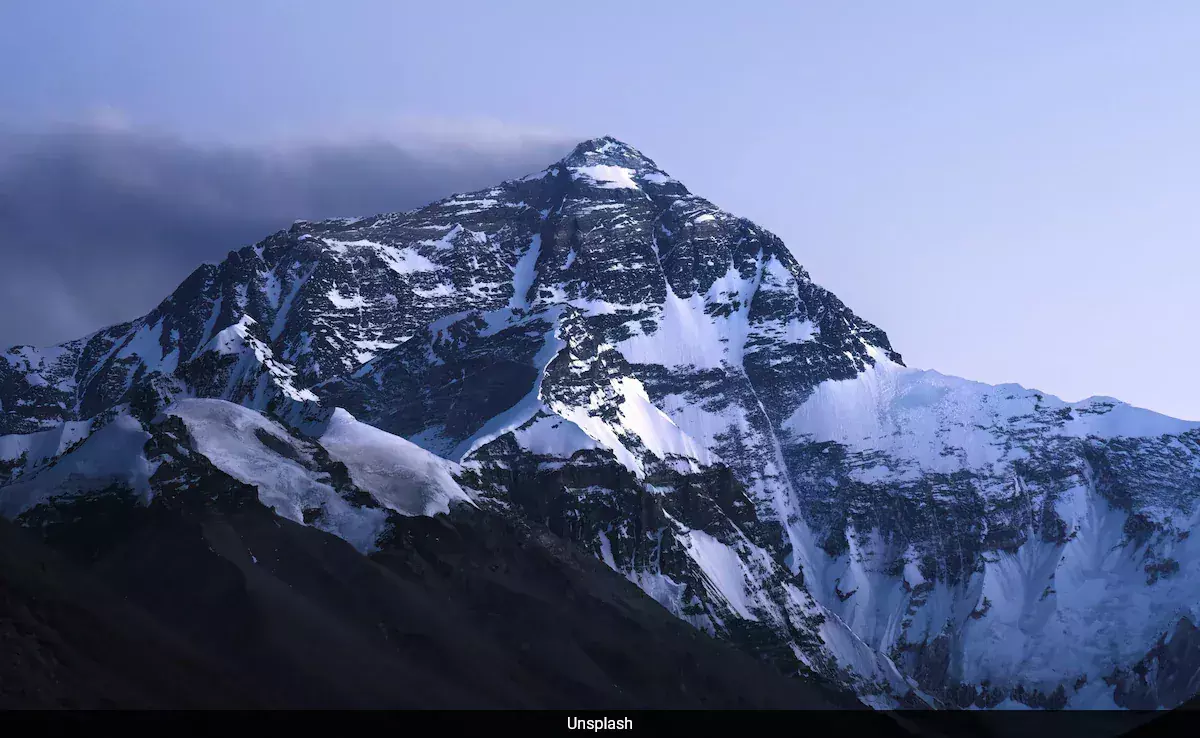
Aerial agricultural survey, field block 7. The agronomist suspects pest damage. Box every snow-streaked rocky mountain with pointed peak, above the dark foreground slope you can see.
[0,138,1200,707]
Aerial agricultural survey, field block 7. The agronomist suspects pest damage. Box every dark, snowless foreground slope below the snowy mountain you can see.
[0,446,873,715]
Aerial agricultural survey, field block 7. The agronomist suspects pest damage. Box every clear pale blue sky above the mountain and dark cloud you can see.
[0,0,1200,419]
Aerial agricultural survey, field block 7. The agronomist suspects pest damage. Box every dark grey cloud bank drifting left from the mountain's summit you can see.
[0,130,570,347]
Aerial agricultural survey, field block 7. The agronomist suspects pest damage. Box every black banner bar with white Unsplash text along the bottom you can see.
[0,709,1200,738]
